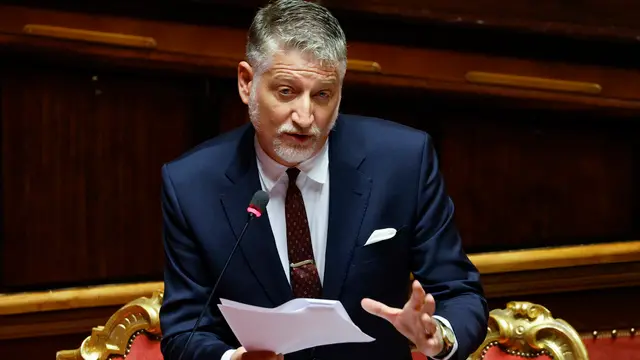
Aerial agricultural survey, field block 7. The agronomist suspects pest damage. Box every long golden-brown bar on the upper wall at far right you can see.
[465,71,602,95]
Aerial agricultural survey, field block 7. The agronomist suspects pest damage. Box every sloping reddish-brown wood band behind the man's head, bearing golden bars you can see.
[6,6,640,111]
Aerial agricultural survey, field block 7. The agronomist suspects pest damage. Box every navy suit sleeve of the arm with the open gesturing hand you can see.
[411,134,489,360]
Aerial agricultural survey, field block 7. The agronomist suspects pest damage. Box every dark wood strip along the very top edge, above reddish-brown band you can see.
[11,0,638,42]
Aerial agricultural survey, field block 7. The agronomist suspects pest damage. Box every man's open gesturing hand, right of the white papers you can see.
[362,280,444,356]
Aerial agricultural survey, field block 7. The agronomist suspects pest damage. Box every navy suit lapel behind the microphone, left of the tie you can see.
[221,127,292,306]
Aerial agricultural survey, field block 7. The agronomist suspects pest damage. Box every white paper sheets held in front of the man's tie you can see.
[218,298,375,354]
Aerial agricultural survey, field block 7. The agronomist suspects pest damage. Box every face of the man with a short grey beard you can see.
[238,52,341,166]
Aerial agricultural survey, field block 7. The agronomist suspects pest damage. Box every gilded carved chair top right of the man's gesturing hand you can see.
[468,301,589,360]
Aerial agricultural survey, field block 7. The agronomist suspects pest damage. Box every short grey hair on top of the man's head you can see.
[246,0,347,80]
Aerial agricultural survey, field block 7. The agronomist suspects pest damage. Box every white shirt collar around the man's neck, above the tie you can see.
[254,137,329,191]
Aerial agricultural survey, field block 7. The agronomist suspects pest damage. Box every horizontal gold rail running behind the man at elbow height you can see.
[0,241,640,316]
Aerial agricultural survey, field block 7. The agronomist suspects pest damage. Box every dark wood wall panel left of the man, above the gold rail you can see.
[2,57,217,289]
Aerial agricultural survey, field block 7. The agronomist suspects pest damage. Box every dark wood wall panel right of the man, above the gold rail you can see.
[440,108,640,252]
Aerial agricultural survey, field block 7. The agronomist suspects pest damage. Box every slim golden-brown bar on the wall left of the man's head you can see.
[22,24,157,49]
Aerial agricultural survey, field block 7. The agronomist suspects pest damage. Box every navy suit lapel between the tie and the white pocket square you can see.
[323,119,372,299]
